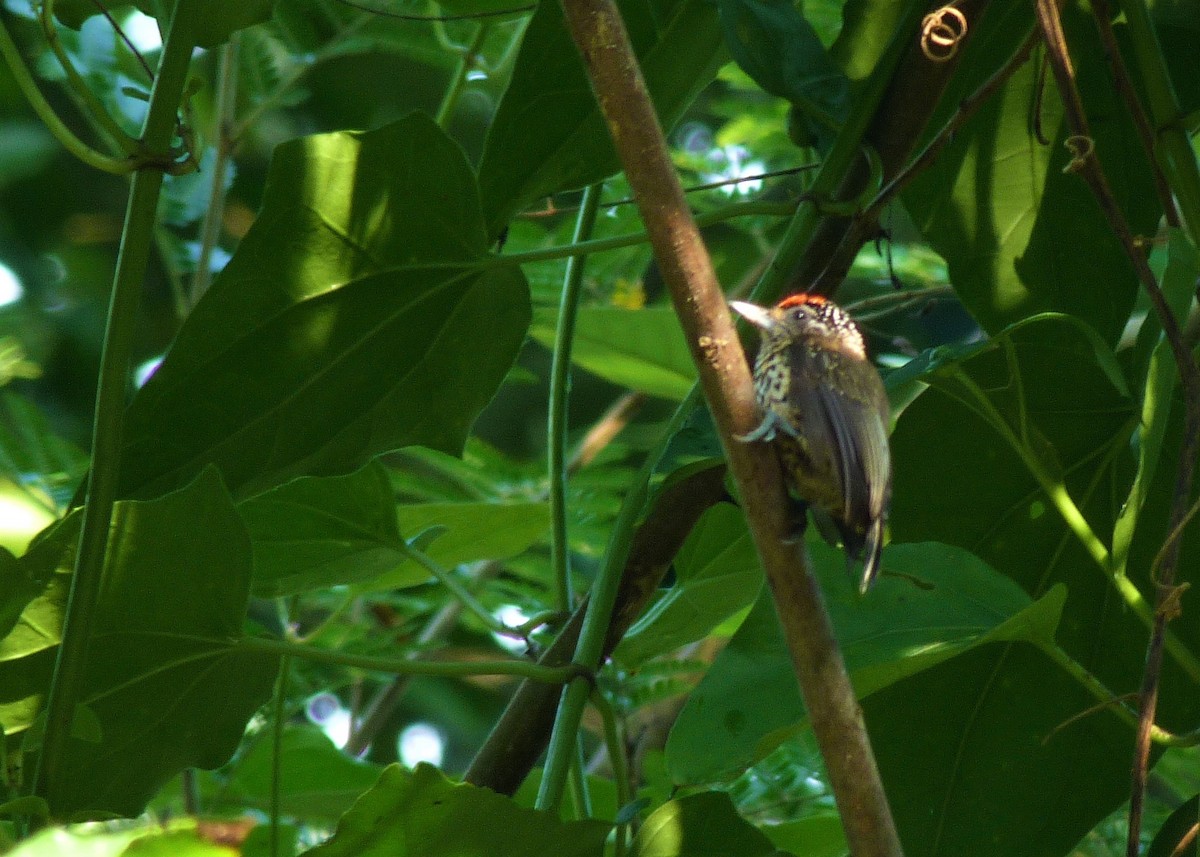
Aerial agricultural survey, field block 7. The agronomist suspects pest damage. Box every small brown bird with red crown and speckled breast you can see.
[730,294,892,593]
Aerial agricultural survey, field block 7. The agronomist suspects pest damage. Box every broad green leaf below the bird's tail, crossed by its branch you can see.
[667,543,1063,784]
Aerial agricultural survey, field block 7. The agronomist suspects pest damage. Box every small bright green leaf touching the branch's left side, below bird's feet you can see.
[613,503,762,667]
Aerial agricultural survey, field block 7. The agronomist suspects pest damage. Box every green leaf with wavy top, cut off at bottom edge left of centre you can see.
[305,765,610,857]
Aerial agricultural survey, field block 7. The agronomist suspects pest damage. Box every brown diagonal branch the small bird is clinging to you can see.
[552,0,901,857]
